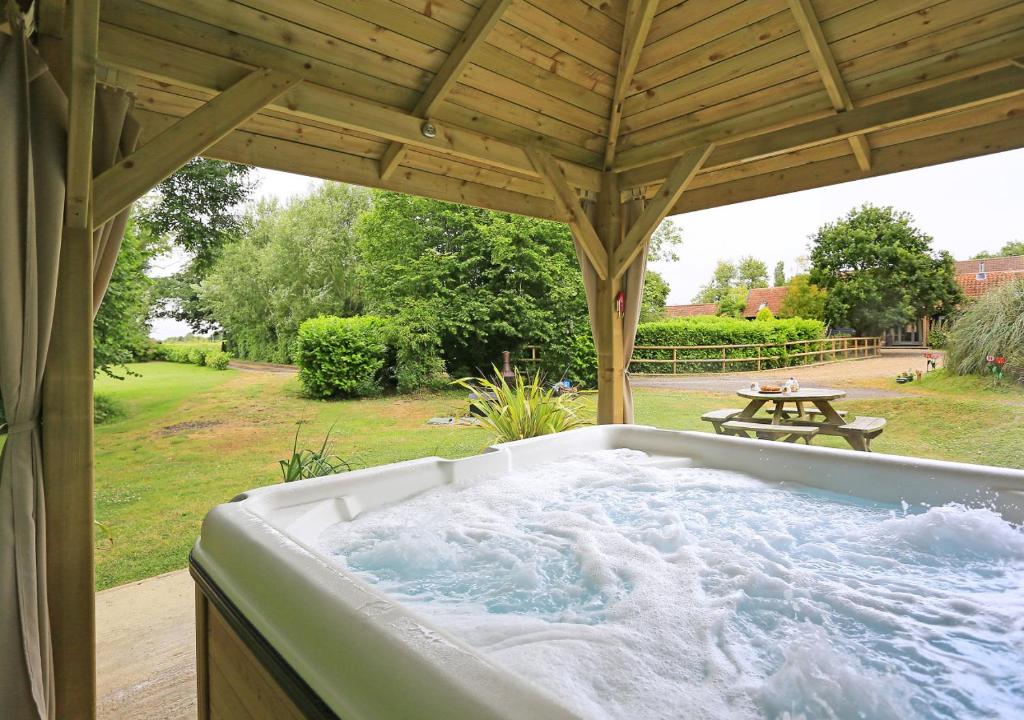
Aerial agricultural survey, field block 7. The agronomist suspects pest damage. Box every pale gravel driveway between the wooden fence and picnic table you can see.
[630,349,926,398]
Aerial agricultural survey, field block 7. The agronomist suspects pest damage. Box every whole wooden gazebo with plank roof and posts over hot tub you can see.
[0,0,1024,719]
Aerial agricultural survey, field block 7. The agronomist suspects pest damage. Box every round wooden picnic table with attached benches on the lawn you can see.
[705,387,886,451]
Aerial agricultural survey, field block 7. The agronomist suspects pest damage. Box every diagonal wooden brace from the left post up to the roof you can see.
[93,70,299,226]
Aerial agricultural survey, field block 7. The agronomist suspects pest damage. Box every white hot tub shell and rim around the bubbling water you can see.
[191,425,1024,720]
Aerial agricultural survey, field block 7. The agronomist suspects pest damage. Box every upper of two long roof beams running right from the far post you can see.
[620,67,1024,189]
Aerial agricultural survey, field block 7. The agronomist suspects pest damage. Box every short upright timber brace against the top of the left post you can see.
[65,0,99,230]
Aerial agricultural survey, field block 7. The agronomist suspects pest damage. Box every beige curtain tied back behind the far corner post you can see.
[575,199,647,423]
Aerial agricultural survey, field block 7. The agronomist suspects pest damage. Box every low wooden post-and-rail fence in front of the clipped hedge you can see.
[520,337,882,375]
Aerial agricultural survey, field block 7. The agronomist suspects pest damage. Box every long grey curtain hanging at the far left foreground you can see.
[0,19,68,720]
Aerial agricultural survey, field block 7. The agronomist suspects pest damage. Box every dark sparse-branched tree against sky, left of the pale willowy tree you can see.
[138,158,255,333]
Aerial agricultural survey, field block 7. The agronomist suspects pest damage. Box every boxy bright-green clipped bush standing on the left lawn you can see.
[295,315,388,397]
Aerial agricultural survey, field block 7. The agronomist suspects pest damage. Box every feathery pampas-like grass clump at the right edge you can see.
[945,281,1024,380]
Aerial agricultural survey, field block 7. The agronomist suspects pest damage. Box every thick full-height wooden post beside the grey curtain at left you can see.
[41,0,99,720]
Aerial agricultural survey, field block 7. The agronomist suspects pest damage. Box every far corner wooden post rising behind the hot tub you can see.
[595,172,626,425]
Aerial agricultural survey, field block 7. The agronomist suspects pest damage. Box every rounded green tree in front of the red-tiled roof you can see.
[810,205,963,335]
